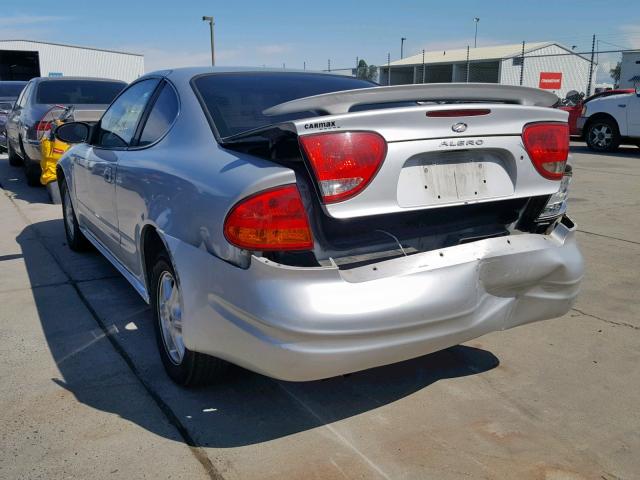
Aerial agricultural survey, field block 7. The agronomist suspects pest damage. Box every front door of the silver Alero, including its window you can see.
[75,78,159,257]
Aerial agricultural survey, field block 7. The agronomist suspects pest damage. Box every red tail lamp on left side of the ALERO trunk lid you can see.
[299,132,387,203]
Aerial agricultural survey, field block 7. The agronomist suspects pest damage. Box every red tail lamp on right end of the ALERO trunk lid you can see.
[522,123,569,180]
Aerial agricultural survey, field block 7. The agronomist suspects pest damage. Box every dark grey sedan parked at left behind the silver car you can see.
[6,77,127,186]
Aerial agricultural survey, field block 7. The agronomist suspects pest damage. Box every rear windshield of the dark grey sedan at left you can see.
[36,80,125,105]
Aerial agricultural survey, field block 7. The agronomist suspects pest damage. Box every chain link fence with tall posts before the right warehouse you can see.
[324,42,640,104]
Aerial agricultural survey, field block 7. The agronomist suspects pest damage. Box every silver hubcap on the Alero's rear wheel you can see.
[157,272,185,365]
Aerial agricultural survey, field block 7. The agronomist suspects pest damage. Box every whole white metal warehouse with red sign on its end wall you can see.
[380,42,591,97]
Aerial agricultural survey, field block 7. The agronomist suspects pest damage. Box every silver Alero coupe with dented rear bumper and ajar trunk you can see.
[56,68,583,385]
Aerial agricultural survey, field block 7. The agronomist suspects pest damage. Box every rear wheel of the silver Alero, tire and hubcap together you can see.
[150,252,228,387]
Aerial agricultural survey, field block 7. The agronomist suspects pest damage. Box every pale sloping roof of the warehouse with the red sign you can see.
[390,42,584,68]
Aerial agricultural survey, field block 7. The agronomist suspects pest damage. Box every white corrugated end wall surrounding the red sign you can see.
[500,45,595,98]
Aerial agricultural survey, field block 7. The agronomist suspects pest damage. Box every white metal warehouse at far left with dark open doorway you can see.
[0,40,144,82]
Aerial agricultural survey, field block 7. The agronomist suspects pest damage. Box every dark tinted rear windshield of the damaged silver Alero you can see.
[193,72,376,138]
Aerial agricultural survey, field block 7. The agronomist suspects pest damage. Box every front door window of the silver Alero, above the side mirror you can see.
[95,78,159,148]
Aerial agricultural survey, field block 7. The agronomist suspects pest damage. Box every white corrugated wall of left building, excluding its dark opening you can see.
[0,40,144,82]
